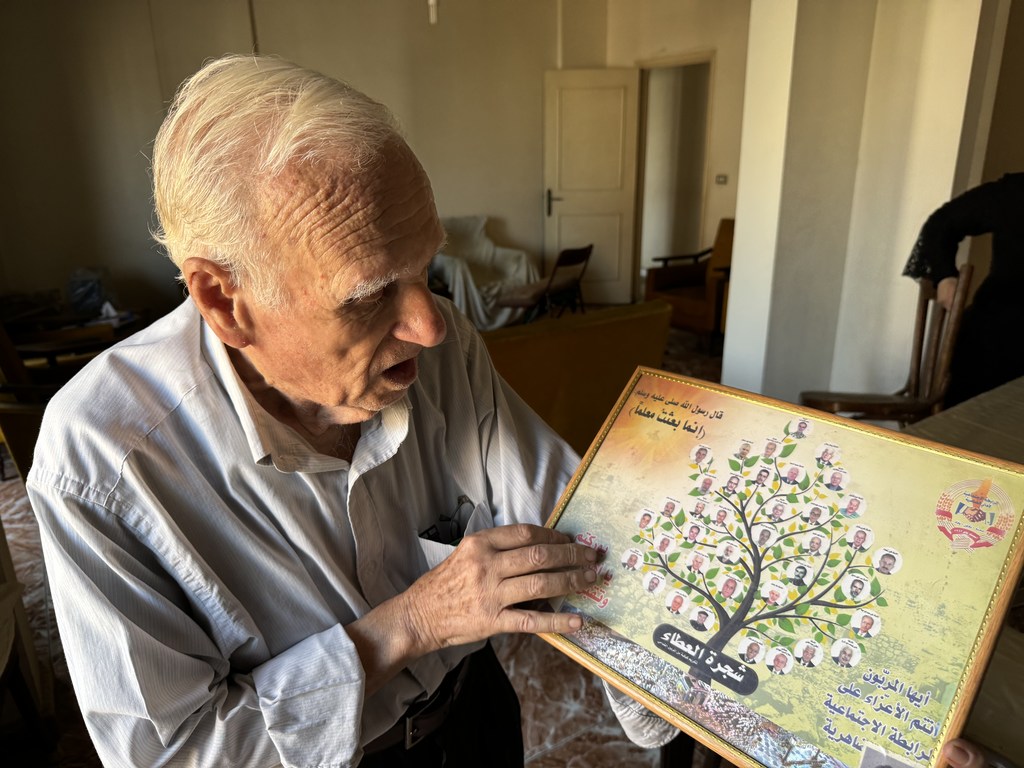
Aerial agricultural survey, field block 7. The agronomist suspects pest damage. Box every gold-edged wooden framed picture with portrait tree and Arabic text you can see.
[544,368,1024,768]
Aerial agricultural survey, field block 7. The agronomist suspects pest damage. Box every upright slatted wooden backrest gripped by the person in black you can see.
[905,264,974,403]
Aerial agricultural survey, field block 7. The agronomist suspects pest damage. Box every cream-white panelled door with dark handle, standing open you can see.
[544,69,640,304]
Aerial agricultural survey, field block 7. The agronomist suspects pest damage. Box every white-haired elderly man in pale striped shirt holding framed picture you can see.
[28,56,678,767]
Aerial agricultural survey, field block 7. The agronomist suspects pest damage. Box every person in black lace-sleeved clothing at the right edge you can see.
[903,173,1024,408]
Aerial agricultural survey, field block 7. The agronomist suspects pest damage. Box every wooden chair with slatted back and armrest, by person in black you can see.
[800,264,974,426]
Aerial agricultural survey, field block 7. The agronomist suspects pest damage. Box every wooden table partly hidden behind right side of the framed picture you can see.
[903,378,1024,766]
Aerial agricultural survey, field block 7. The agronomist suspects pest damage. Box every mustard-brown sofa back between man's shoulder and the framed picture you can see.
[482,301,672,455]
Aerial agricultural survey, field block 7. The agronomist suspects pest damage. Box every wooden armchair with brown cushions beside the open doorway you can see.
[644,219,736,336]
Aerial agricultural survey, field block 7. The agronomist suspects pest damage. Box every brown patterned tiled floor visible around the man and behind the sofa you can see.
[0,331,721,768]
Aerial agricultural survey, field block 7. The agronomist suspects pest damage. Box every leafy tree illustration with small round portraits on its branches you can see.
[633,419,896,680]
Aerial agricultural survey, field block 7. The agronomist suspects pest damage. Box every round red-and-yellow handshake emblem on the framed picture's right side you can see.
[935,478,1015,551]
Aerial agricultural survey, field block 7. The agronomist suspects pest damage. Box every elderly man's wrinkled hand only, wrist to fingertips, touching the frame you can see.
[404,525,597,653]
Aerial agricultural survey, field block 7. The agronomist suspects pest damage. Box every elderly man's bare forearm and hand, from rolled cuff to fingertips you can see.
[345,525,597,695]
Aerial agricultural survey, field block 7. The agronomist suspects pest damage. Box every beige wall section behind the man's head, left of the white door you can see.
[256,0,557,262]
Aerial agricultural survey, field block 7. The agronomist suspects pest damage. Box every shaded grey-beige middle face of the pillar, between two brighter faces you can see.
[763,0,876,399]
